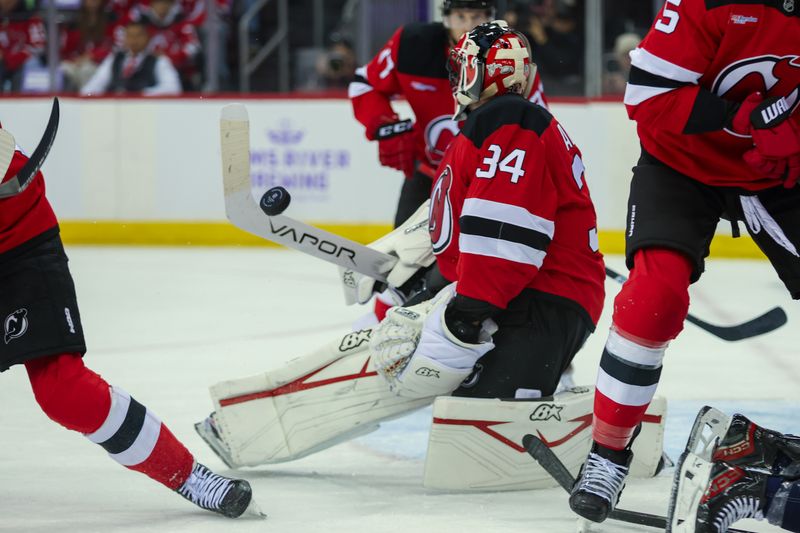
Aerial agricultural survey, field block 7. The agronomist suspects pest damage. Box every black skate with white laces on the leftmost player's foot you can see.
[177,463,263,518]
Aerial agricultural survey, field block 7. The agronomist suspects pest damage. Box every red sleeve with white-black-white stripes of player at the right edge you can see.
[625,0,737,134]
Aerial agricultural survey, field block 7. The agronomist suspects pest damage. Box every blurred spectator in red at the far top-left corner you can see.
[0,0,46,92]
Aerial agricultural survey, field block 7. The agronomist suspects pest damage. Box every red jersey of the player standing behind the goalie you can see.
[348,22,546,166]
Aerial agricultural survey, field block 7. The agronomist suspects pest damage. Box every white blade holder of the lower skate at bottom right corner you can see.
[667,450,713,533]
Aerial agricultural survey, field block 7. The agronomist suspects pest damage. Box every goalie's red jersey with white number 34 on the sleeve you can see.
[430,94,605,324]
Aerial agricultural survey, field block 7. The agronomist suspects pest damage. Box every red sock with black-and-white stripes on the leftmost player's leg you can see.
[25,354,194,489]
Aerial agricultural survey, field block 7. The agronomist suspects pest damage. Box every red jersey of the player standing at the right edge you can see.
[625,0,800,191]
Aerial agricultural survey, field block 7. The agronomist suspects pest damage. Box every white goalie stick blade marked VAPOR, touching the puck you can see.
[220,104,397,281]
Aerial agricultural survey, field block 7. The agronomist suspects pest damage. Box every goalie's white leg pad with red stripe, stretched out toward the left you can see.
[206,329,433,466]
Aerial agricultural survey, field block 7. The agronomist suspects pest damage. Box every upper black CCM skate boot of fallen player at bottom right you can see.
[712,414,800,475]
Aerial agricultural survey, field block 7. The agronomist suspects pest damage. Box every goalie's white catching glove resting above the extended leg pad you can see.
[370,283,497,398]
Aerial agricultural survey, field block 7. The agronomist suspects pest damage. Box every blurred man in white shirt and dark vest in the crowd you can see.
[81,21,181,96]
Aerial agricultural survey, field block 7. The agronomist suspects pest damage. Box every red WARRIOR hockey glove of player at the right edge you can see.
[732,93,800,189]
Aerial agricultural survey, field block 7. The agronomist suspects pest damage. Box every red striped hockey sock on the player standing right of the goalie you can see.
[592,249,692,450]
